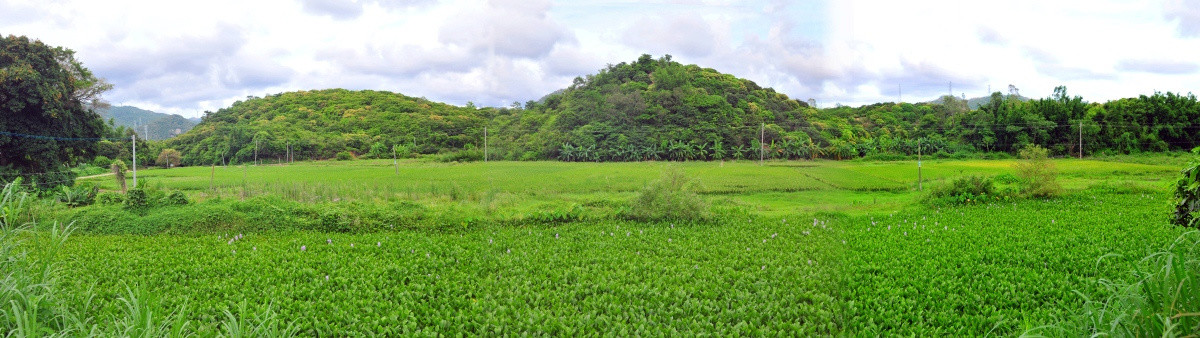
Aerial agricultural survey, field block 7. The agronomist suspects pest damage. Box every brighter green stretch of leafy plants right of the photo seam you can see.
[844,191,1196,337]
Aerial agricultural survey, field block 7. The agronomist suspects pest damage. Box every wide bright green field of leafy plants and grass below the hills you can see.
[7,159,1200,336]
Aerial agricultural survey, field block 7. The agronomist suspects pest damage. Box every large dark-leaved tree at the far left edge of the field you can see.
[0,35,110,188]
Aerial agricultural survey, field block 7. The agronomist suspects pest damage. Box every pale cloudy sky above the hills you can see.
[0,0,1200,116]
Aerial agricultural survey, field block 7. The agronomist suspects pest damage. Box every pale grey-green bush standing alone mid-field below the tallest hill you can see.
[626,168,708,221]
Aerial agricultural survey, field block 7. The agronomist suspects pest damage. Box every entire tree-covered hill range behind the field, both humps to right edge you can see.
[164,55,1200,164]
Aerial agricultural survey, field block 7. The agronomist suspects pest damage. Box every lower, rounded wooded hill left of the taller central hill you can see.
[171,89,485,164]
